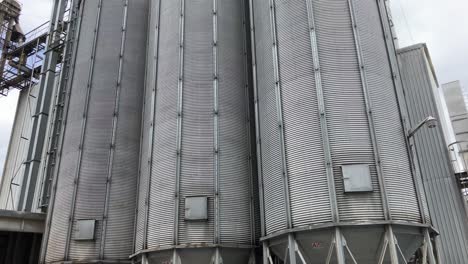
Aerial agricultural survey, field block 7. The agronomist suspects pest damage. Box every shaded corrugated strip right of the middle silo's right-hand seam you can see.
[217,0,254,244]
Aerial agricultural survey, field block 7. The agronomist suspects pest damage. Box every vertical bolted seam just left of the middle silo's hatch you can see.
[173,0,185,249]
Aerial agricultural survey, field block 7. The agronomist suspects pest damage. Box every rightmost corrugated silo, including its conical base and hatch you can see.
[250,0,436,263]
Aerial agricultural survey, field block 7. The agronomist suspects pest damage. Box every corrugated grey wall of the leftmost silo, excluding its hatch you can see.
[46,0,148,262]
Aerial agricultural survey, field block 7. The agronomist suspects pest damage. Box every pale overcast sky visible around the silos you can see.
[0,0,468,174]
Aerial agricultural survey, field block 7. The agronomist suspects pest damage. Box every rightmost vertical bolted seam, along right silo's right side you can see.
[376,0,427,223]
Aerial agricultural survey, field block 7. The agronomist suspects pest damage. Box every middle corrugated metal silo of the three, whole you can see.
[134,0,258,264]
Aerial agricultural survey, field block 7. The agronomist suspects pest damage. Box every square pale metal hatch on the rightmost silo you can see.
[341,164,374,193]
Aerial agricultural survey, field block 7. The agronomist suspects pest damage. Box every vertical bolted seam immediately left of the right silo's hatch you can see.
[307,0,340,223]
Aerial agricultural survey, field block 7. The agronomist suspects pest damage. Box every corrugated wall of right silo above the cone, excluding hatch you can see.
[253,0,421,234]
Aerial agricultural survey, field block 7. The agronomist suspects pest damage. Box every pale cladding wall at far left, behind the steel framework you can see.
[0,86,38,210]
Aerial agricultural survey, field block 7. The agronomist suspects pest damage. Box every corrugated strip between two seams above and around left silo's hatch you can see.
[67,1,123,259]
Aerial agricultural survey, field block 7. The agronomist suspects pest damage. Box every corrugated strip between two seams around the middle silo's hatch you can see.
[178,0,215,244]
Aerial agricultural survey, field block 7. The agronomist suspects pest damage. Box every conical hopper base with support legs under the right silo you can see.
[264,224,435,264]
